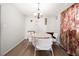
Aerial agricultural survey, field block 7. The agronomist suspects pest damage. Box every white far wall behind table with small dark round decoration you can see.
[25,16,46,38]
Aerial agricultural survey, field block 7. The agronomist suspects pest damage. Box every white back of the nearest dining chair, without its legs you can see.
[36,38,52,50]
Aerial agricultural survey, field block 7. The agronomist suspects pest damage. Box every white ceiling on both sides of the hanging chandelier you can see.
[14,3,72,16]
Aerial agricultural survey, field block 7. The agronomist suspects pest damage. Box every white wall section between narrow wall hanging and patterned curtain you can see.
[47,16,59,32]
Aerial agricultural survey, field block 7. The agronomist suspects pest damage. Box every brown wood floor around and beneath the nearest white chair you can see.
[5,40,68,56]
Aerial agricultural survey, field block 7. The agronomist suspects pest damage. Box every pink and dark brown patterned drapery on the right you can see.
[60,3,79,55]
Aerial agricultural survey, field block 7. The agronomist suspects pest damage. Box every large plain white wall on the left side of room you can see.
[1,4,25,55]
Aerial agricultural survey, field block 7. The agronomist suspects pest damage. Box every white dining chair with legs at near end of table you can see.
[34,38,54,55]
